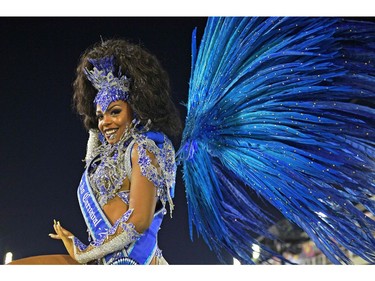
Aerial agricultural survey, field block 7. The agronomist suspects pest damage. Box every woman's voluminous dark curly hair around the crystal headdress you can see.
[73,39,182,137]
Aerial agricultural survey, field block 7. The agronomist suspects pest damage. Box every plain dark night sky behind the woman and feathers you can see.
[0,17,235,264]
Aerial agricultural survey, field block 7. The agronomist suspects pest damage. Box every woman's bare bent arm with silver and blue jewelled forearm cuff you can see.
[55,145,158,263]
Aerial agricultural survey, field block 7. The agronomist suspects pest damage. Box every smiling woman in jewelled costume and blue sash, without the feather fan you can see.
[50,40,181,264]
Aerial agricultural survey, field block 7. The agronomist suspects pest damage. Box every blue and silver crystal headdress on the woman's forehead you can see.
[84,56,129,112]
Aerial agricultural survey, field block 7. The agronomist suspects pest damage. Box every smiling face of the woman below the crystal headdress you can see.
[96,100,133,144]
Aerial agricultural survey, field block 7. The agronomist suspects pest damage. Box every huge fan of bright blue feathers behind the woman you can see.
[178,17,375,263]
